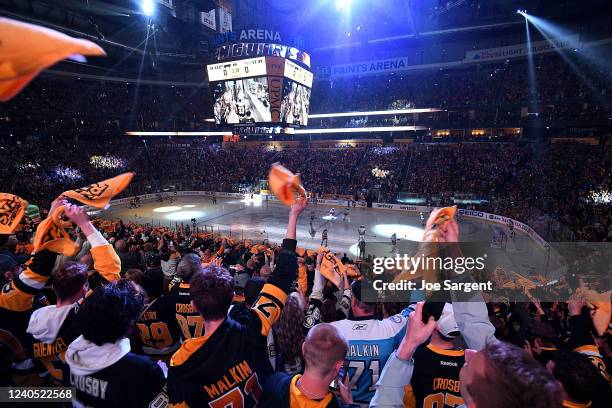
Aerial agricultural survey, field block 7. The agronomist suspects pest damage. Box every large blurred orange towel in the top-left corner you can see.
[0,18,106,102]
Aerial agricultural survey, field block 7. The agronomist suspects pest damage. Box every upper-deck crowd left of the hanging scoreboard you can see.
[0,77,212,136]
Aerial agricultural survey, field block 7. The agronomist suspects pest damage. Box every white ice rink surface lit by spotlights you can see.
[98,196,560,279]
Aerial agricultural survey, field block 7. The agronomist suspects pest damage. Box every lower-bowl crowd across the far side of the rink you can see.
[0,138,612,241]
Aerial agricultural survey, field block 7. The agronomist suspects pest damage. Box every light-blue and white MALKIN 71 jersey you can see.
[331,309,408,404]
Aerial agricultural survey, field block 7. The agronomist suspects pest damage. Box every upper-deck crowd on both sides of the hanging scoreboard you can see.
[0,51,612,135]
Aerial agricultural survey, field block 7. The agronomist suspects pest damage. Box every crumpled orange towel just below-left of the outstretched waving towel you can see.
[34,205,79,256]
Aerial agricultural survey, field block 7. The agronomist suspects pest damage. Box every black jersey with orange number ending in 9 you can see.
[136,296,181,357]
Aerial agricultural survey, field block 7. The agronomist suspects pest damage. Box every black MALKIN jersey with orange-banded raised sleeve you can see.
[168,284,287,408]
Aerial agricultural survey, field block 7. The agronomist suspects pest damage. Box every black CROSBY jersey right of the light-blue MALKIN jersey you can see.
[404,344,465,408]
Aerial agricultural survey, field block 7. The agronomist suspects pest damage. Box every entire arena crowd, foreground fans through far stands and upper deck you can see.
[0,13,612,408]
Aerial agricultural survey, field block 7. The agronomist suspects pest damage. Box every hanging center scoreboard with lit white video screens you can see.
[206,56,314,126]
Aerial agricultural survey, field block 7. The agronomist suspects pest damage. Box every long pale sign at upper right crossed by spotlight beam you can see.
[464,34,580,62]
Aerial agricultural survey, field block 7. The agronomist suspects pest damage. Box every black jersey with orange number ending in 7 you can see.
[168,281,204,341]
